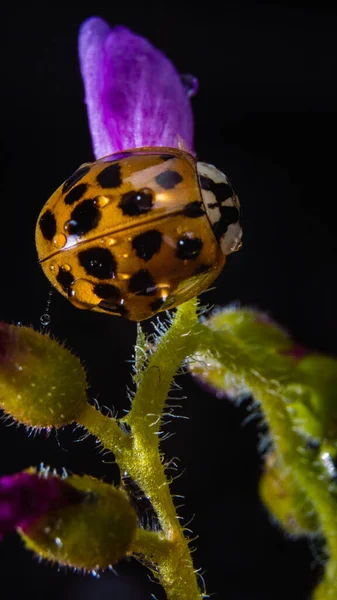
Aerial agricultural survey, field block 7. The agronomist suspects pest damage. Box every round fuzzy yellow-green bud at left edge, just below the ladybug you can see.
[0,323,86,428]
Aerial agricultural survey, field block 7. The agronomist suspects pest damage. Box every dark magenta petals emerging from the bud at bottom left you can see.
[0,472,83,540]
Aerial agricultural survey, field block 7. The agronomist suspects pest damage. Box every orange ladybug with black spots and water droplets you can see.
[36,147,242,321]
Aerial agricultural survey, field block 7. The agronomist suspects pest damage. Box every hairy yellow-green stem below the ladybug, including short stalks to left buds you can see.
[80,299,203,600]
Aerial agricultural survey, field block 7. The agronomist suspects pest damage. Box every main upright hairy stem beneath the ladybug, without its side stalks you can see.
[124,300,201,600]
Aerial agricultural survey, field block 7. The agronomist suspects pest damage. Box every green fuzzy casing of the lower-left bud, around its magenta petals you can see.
[21,475,137,570]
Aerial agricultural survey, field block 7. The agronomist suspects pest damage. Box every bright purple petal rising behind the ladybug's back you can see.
[79,17,197,158]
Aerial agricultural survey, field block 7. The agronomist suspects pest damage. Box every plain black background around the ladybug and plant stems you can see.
[0,1,337,600]
